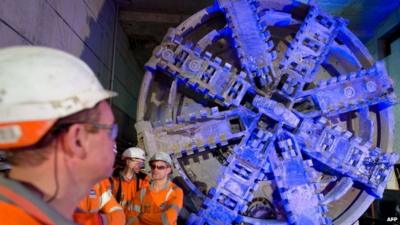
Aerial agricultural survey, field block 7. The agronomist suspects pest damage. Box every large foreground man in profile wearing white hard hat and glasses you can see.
[0,46,118,225]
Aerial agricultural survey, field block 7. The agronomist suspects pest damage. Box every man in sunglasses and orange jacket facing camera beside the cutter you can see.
[127,152,183,225]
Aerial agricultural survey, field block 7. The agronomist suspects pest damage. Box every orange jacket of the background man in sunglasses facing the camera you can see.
[126,181,183,225]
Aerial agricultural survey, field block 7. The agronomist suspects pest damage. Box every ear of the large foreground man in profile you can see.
[62,124,87,159]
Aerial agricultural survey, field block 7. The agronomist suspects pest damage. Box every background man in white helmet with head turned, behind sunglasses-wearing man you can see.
[111,147,150,221]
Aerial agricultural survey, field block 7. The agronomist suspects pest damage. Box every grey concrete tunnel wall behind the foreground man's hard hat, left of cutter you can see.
[0,0,143,148]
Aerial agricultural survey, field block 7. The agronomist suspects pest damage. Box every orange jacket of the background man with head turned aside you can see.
[111,171,150,218]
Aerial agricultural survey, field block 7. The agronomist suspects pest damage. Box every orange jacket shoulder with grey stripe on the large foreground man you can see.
[0,176,74,225]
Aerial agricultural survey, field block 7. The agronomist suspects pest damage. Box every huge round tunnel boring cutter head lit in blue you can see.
[136,0,397,225]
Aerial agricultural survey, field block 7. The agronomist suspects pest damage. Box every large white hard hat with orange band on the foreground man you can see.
[0,46,116,149]
